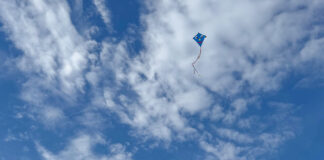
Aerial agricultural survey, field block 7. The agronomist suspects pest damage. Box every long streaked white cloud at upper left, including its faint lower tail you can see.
[0,0,96,126]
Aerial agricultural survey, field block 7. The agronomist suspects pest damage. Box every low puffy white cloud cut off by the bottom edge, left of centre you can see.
[36,134,132,160]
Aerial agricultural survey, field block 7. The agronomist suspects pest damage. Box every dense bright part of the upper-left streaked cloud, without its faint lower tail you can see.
[1,0,88,99]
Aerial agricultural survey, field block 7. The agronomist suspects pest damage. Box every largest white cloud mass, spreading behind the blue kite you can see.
[95,0,320,159]
